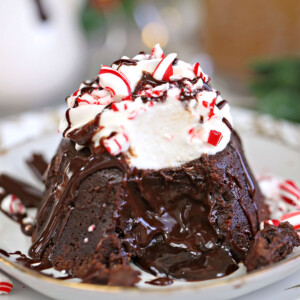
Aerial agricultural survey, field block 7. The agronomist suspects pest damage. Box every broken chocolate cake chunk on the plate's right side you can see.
[244,222,300,272]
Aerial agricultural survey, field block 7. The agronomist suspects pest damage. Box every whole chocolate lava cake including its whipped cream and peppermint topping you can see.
[29,45,298,285]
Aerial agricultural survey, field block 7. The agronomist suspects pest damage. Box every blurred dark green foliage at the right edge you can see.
[250,58,300,122]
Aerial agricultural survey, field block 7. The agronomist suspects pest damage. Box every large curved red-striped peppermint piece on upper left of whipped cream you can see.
[98,66,131,100]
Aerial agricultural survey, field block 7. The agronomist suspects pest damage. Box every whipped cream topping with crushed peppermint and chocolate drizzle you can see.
[59,45,232,169]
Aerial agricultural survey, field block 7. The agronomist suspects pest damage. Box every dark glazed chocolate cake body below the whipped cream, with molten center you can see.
[29,131,268,280]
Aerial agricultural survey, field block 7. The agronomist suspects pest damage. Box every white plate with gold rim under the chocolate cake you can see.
[0,109,300,300]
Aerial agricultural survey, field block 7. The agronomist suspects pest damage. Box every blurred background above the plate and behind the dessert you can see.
[0,0,300,122]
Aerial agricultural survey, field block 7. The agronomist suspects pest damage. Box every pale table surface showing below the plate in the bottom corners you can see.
[0,271,300,300]
